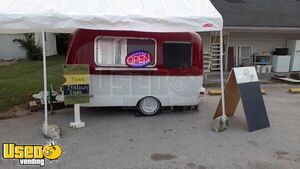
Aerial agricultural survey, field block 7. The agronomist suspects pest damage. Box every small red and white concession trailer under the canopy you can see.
[67,29,204,115]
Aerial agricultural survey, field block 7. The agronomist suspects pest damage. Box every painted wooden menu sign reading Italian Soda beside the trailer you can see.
[63,64,90,105]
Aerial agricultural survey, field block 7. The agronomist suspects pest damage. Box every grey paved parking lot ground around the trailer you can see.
[0,85,300,169]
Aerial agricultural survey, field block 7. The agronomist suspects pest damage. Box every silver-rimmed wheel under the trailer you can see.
[137,96,161,116]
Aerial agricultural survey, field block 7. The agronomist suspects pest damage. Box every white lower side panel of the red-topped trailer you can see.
[81,75,203,107]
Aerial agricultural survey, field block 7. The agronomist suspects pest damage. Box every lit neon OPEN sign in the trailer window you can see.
[125,50,152,68]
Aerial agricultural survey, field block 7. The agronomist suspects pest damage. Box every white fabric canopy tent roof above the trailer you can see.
[0,0,223,33]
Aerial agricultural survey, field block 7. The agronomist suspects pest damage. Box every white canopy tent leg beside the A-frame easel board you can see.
[220,30,226,116]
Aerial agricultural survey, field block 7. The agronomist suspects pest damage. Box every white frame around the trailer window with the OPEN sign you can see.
[94,36,157,69]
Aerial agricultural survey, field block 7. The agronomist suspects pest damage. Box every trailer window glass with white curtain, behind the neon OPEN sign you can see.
[95,37,156,67]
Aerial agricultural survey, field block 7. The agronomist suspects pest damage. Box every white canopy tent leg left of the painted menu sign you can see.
[42,30,48,135]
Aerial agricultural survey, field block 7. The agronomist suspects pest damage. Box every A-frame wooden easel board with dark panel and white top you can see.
[213,67,270,131]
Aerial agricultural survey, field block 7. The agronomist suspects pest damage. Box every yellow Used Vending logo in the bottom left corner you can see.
[2,140,63,167]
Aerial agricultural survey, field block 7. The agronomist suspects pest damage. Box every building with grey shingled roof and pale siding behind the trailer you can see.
[200,0,300,70]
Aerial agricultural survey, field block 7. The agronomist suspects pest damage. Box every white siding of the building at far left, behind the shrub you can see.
[0,34,26,60]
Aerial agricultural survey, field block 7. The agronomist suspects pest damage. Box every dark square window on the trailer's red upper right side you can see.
[163,42,192,69]
